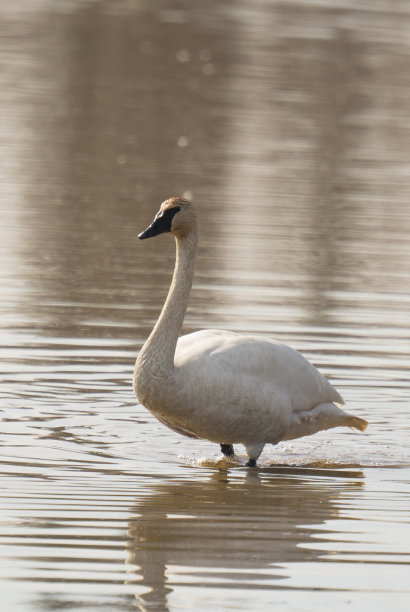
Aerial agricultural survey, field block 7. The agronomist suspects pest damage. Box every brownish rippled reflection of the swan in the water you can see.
[127,468,363,610]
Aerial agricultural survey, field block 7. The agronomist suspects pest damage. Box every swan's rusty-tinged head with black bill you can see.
[138,197,196,240]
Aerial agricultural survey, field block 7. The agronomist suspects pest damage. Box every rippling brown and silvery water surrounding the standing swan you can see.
[0,0,410,612]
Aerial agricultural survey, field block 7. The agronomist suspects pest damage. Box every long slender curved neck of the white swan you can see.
[137,230,198,373]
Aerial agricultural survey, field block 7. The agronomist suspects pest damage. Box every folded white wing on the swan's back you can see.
[175,330,344,412]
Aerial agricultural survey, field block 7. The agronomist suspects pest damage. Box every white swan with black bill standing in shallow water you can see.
[133,197,367,467]
